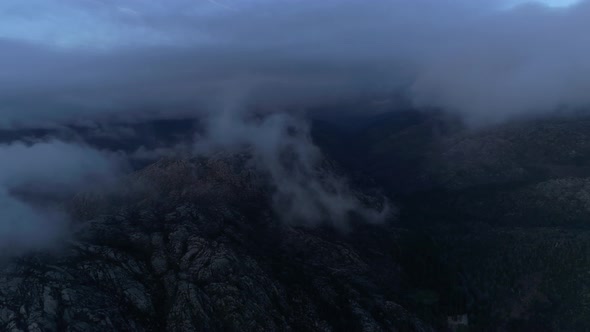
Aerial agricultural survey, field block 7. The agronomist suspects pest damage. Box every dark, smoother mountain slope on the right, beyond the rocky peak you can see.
[319,112,590,331]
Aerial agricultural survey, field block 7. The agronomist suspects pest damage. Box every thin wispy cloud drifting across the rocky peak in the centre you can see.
[195,111,392,227]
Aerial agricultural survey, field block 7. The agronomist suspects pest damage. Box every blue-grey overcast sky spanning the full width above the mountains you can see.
[0,0,590,127]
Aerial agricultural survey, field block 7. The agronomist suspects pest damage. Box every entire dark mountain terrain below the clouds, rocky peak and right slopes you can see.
[5,110,590,331]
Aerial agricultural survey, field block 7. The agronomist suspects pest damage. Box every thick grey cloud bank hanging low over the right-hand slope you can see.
[411,3,590,124]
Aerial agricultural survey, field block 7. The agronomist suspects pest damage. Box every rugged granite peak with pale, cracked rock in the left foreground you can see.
[0,156,431,331]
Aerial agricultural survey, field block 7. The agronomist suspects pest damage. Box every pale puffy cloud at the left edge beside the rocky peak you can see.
[0,141,120,254]
